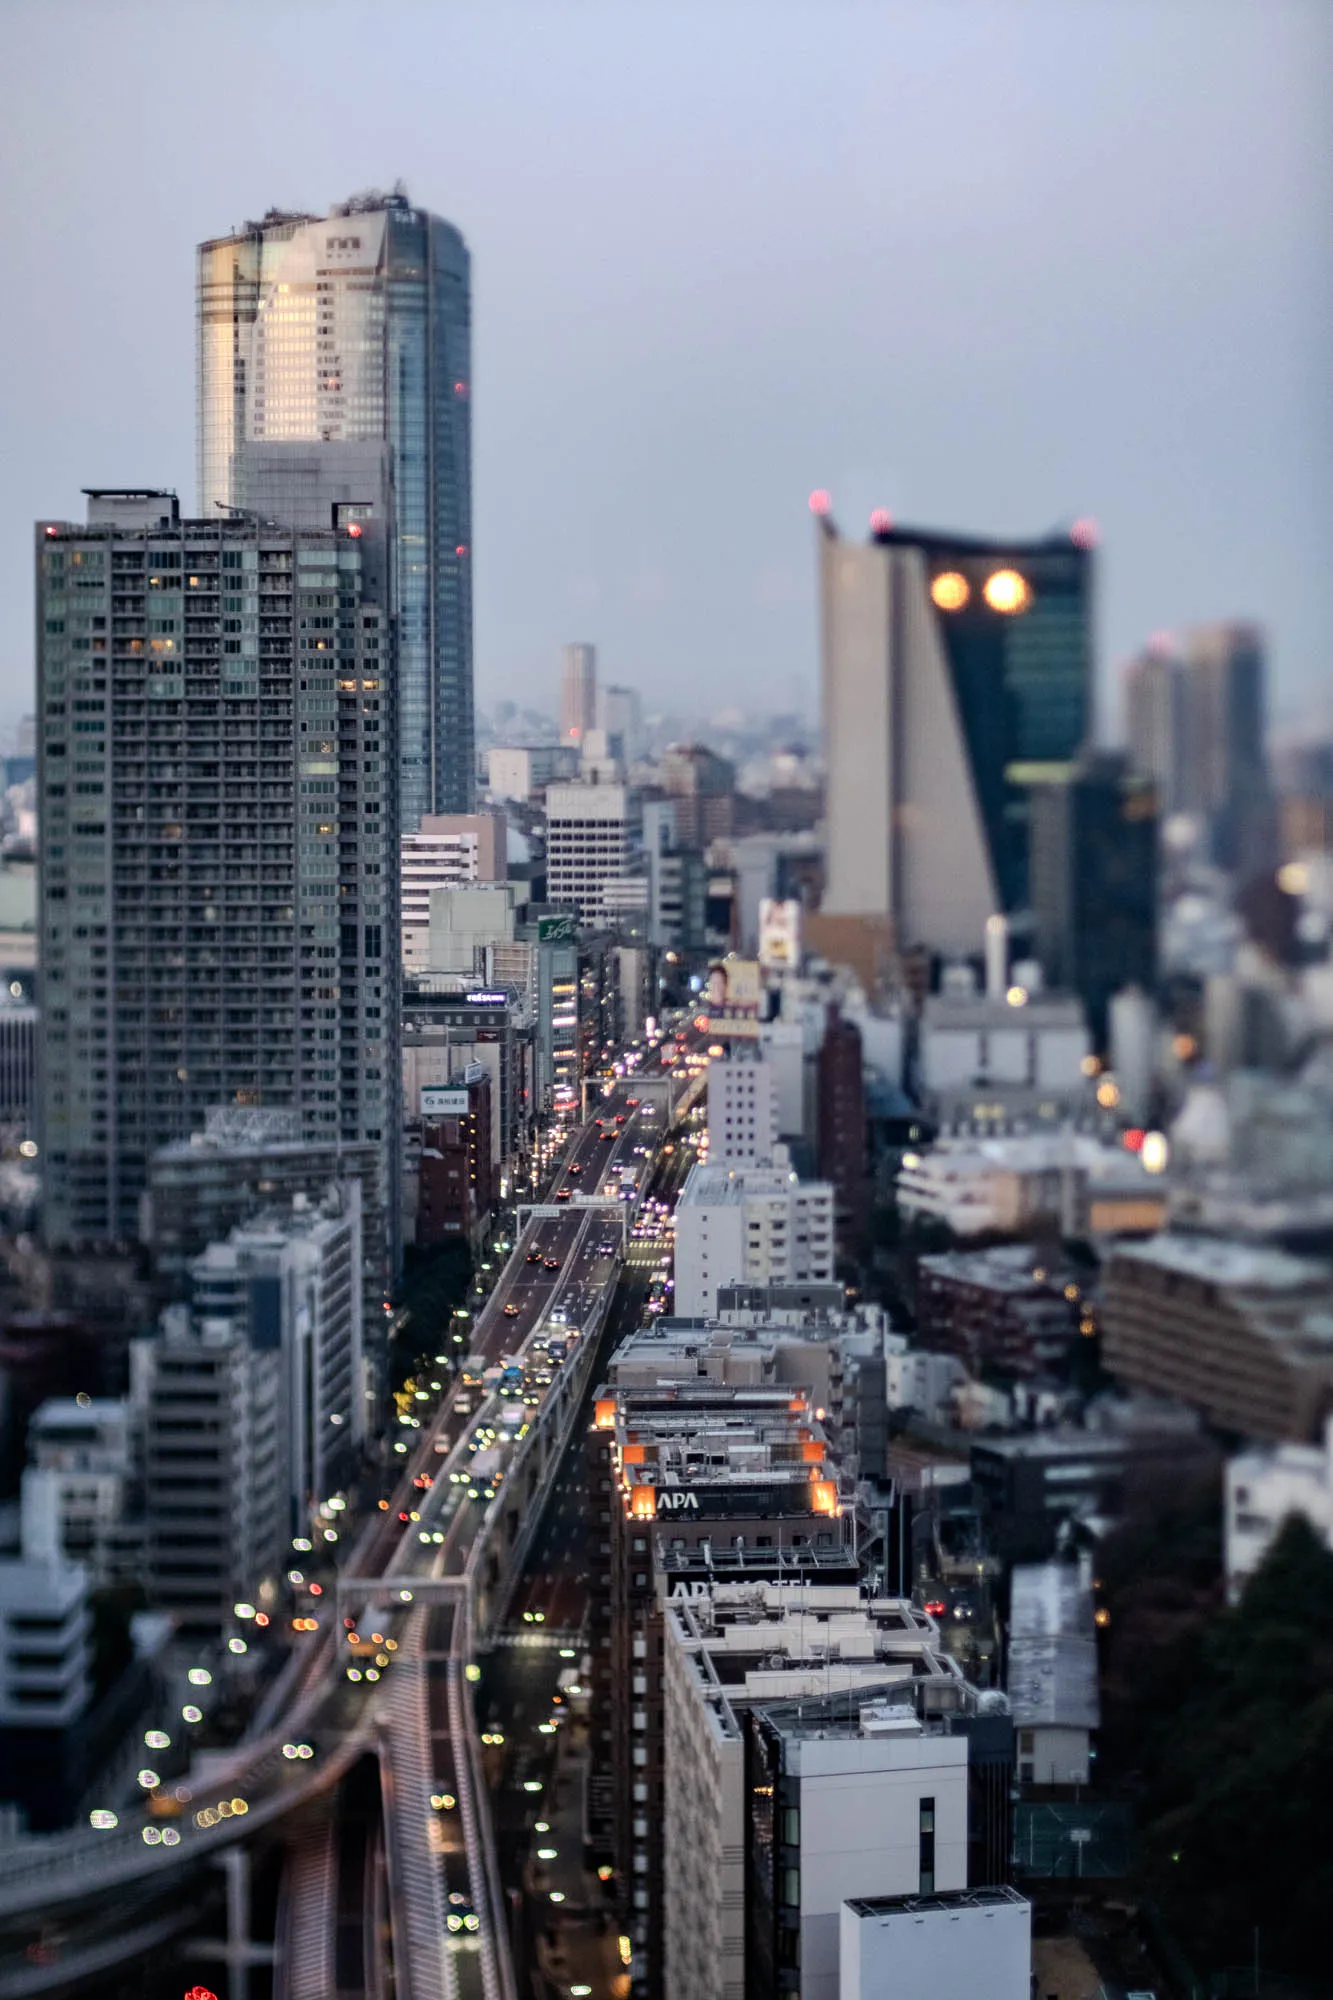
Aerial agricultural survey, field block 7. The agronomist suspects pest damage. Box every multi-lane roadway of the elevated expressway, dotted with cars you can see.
[0,1040,684,2000]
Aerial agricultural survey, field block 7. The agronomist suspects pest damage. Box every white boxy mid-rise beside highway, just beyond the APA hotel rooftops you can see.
[675,1154,833,1318]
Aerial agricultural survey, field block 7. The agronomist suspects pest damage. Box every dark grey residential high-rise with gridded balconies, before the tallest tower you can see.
[36,492,398,1244]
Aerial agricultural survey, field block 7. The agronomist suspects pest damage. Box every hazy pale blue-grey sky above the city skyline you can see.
[0,0,1333,740]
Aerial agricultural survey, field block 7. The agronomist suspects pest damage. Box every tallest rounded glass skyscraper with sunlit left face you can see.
[198,190,472,832]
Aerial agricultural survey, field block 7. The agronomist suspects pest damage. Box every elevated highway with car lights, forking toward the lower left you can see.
[0,1056,684,2000]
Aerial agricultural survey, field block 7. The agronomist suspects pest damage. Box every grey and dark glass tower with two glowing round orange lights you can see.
[819,516,1093,954]
